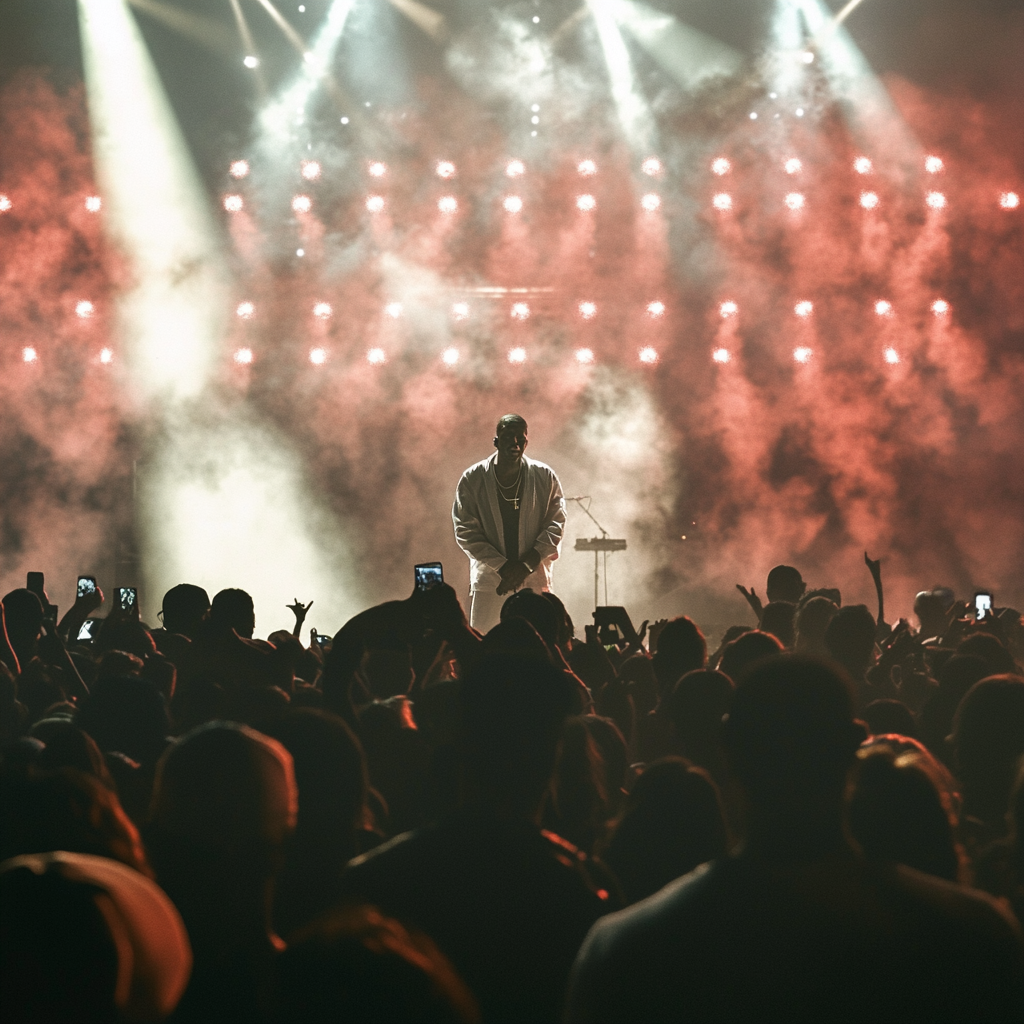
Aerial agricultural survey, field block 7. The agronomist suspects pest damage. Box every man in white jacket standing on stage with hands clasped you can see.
[452,414,565,633]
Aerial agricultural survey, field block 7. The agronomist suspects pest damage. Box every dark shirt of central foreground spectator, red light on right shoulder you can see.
[335,810,615,1021]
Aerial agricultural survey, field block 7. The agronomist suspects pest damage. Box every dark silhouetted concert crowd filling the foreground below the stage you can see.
[0,556,1024,1022]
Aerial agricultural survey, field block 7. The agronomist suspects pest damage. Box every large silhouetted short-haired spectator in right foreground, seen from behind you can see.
[567,656,1024,1021]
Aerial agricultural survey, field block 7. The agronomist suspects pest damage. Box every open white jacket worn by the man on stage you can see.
[452,452,565,591]
